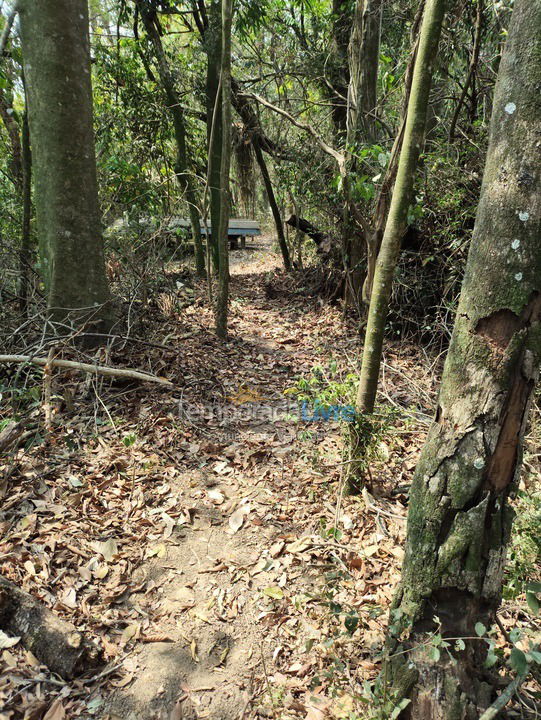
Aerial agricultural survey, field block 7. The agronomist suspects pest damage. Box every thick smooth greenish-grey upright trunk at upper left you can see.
[20,0,110,327]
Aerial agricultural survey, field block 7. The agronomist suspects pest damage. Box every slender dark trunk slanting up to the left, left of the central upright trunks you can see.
[137,0,205,277]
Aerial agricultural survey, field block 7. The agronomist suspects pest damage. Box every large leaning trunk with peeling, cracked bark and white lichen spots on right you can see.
[390,0,541,720]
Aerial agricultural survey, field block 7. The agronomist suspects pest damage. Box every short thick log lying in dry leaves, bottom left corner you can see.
[0,577,101,680]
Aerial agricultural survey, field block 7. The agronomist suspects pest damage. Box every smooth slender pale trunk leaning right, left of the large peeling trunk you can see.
[357,0,446,413]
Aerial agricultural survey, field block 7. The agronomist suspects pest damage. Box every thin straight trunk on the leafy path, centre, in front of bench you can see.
[216,0,233,339]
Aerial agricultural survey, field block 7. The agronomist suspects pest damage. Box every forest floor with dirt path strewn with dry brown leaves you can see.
[0,241,536,720]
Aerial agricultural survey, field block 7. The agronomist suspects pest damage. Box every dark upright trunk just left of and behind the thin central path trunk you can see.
[204,0,223,270]
